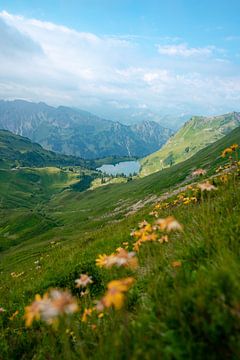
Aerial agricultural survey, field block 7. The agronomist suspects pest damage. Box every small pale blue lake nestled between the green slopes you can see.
[97,161,140,176]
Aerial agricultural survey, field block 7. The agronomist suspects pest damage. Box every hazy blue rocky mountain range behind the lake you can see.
[0,100,172,159]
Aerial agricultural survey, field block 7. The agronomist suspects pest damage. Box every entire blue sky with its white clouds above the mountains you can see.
[0,0,240,122]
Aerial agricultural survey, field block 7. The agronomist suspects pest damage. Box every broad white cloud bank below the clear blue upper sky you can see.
[0,11,240,118]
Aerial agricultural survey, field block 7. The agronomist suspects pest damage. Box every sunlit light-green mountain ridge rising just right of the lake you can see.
[140,112,240,176]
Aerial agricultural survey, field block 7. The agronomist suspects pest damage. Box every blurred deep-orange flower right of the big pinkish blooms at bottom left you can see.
[97,277,134,310]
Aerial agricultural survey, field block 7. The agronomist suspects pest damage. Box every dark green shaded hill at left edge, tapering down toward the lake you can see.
[0,130,94,168]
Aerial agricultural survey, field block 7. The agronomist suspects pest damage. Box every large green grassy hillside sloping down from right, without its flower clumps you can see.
[0,128,240,359]
